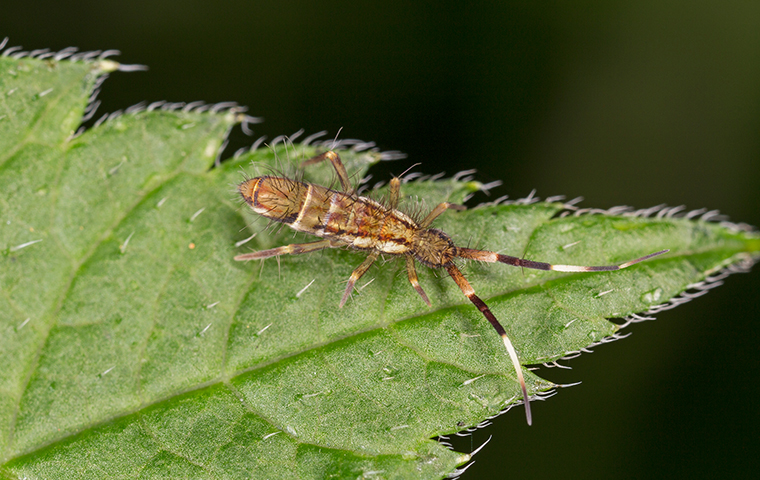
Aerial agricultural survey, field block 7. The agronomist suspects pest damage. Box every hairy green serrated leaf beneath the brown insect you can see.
[0,50,760,479]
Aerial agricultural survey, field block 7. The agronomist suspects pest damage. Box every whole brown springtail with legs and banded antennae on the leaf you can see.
[235,151,668,425]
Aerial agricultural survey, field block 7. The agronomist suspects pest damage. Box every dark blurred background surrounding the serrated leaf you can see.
[5,0,760,479]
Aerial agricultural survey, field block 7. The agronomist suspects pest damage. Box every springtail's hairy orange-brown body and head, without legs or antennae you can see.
[239,176,446,260]
